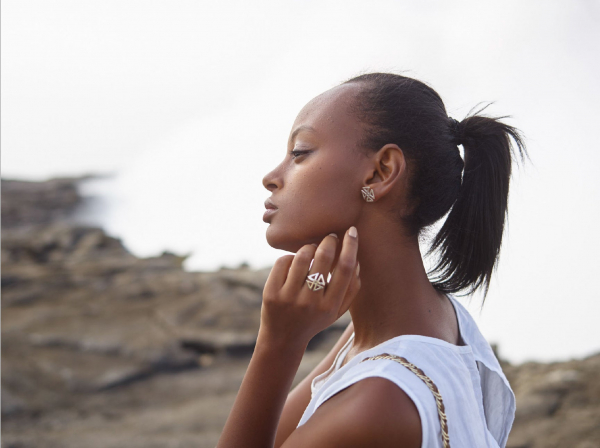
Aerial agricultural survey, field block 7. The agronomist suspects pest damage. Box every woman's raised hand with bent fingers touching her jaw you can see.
[259,227,360,345]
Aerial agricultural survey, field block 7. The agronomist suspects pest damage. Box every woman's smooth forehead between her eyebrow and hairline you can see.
[290,84,361,142]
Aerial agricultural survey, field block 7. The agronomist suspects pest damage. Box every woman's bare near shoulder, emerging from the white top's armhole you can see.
[282,377,422,448]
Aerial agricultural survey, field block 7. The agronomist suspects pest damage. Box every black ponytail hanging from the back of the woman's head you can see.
[428,109,527,302]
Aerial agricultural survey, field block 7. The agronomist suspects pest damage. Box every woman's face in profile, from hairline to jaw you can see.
[263,84,368,253]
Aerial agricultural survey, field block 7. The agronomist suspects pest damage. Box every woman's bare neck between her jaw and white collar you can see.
[350,216,451,351]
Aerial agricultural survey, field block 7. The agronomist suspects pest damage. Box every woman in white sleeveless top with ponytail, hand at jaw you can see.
[218,73,525,448]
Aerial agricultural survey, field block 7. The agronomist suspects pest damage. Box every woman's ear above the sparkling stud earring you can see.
[364,143,407,201]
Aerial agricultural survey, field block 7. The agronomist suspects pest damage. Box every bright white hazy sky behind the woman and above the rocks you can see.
[1,0,600,362]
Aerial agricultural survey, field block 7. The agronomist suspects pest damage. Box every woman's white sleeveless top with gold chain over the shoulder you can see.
[298,295,516,448]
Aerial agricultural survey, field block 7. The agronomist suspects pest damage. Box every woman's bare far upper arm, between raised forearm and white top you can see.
[275,321,354,448]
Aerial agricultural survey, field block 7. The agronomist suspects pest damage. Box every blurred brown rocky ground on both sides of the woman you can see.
[2,178,600,448]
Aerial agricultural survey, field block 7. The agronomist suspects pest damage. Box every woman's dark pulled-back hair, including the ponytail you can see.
[343,73,527,302]
